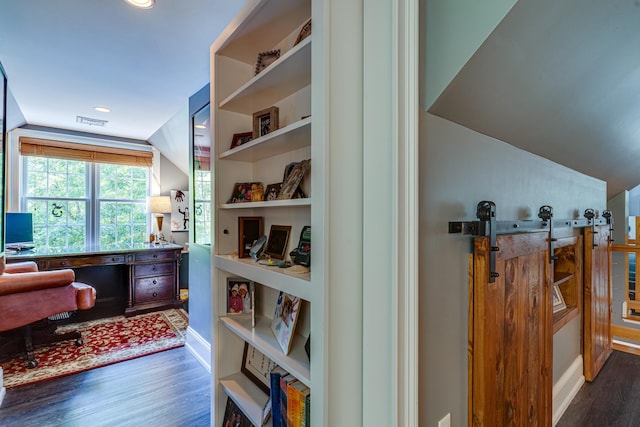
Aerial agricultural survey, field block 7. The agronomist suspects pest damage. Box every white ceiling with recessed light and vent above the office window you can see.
[0,0,244,140]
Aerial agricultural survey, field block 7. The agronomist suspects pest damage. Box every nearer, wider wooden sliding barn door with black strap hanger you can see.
[469,233,553,427]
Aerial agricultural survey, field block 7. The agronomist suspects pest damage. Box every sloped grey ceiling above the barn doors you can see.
[429,0,640,197]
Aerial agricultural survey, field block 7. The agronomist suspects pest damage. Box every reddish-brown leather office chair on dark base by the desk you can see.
[0,258,96,368]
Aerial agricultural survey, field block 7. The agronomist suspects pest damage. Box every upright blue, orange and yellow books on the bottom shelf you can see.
[270,366,311,427]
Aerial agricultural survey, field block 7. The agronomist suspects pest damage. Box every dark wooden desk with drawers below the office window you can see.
[6,243,182,320]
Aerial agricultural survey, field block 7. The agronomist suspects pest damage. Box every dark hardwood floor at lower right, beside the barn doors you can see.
[556,351,640,427]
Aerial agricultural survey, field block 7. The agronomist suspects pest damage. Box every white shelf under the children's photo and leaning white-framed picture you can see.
[220,316,311,388]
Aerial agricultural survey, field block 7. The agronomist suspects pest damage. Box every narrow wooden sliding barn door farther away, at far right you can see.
[583,225,612,381]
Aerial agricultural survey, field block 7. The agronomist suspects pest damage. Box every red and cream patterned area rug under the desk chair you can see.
[2,309,188,388]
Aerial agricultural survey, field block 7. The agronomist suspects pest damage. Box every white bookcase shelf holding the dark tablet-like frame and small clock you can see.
[214,255,311,302]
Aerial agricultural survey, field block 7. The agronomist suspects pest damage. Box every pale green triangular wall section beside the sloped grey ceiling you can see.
[421,0,516,109]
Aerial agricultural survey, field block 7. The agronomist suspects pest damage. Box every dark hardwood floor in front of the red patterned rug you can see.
[0,347,211,427]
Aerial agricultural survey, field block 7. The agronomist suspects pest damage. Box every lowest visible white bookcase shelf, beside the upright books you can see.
[220,372,272,426]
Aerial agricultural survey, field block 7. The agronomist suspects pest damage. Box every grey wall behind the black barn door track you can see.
[419,112,606,426]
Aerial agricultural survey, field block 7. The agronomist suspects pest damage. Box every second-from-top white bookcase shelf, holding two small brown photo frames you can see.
[219,117,311,162]
